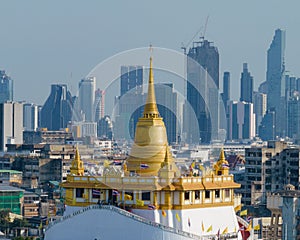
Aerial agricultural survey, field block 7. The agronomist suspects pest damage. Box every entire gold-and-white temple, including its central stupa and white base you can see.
[46,57,242,240]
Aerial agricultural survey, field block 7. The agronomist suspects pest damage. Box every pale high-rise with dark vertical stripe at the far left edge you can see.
[0,102,23,151]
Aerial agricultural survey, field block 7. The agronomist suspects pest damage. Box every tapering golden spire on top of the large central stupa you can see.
[143,56,159,118]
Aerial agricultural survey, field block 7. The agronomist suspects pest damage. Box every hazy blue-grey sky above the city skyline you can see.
[0,0,300,104]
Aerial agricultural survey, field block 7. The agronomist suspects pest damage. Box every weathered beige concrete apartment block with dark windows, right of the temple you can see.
[242,141,290,207]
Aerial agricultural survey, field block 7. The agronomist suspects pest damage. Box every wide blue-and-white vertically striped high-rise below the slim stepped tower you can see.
[228,101,255,141]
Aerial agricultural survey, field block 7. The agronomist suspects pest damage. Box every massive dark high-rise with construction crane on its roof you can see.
[187,39,219,143]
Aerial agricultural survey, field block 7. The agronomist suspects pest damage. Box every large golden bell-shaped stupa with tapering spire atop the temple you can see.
[127,57,177,176]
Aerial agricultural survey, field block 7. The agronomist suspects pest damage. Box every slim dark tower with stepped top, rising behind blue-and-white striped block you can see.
[240,63,253,103]
